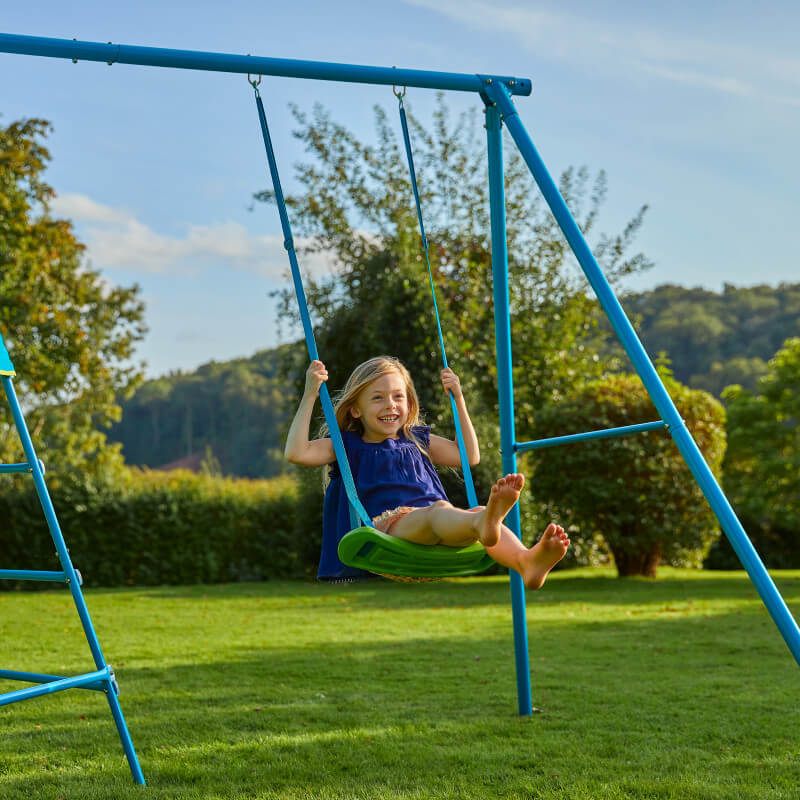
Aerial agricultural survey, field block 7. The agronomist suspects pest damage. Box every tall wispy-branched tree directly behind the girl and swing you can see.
[266,101,649,496]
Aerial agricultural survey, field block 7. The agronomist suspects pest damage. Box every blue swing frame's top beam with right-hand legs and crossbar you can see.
[0,34,800,740]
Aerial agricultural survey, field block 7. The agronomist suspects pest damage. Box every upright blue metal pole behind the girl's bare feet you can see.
[486,106,533,716]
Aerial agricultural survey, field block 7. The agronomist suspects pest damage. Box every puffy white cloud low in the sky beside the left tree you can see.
[51,194,332,280]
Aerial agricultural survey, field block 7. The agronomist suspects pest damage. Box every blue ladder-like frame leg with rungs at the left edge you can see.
[0,336,145,784]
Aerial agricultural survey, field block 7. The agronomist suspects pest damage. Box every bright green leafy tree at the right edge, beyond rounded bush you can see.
[724,338,800,567]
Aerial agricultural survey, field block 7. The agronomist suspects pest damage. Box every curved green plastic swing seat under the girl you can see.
[339,527,494,578]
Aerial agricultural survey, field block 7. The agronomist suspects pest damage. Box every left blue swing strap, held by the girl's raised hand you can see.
[251,81,372,528]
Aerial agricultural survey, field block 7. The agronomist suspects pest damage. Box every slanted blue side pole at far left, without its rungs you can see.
[2,376,145,785]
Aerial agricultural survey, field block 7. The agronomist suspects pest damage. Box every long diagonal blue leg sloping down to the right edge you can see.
[485,83,800,664]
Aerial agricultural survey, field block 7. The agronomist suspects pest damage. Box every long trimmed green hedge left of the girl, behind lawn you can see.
[0,472,308,588]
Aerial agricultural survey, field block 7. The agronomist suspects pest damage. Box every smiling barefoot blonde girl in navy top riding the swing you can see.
[284,356,570,589]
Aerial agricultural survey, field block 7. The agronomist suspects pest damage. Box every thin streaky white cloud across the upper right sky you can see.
[406,0,800,105]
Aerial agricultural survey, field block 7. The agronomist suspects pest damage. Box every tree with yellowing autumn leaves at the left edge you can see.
[0,119,145,482]
